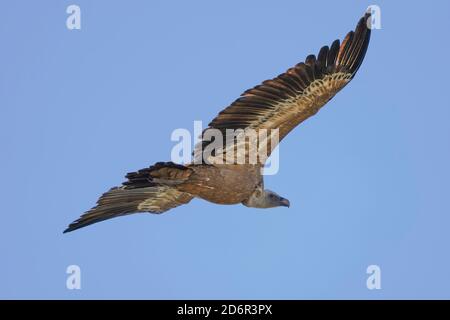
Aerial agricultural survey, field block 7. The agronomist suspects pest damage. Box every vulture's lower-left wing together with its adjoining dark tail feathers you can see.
[64,162,193,233]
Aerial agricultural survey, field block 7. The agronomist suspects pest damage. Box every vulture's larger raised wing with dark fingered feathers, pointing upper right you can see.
[195,13,371,164]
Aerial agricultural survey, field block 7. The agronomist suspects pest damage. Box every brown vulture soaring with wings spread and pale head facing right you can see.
[64,12,371,233]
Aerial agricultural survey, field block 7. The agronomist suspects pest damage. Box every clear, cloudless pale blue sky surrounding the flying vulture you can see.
[0,0,450,299]
